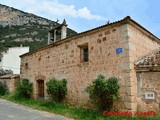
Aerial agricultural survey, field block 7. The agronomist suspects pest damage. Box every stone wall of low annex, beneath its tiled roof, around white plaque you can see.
[137,72,160,112]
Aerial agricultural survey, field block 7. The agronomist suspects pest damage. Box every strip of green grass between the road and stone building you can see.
[2,94,160,120]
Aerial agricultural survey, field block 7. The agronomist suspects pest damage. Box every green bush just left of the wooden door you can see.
[16,79,32,98]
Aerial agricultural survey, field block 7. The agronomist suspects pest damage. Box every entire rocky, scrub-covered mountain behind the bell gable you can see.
[0,4,77,51]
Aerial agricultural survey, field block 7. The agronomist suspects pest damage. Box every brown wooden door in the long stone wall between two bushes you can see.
[37,80,44,98]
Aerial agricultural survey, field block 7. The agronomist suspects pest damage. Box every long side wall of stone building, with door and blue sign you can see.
[21,24,129,109]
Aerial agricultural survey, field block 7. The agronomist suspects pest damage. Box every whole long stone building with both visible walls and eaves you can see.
[21,17,160,111]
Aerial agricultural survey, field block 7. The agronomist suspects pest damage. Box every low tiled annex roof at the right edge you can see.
[135,49,160,70]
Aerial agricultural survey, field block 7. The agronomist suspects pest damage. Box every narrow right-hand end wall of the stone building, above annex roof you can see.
[125,25,160,111]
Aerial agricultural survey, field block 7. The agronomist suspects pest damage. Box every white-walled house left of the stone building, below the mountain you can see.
[0,47,29,74]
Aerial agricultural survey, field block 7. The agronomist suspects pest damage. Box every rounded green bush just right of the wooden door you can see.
[46,78,67,102]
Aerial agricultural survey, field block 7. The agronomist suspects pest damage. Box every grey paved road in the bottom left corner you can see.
[0,99,72,120]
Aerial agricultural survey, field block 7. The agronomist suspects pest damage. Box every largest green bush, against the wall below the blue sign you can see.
[86,75,119,111]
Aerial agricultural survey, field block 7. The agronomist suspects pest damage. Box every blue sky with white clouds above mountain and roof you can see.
[0,0,160,38]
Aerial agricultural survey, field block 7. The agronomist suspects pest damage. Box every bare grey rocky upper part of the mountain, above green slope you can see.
[0,4,53,27]
